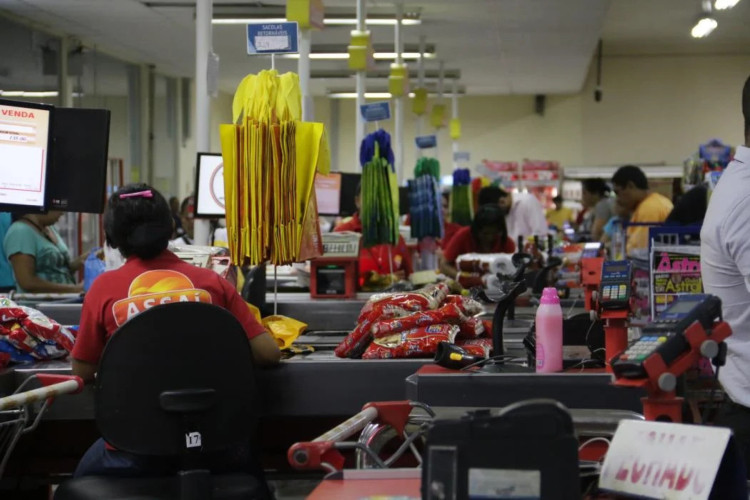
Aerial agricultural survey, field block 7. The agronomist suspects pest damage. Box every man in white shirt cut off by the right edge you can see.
[701,73,750,473]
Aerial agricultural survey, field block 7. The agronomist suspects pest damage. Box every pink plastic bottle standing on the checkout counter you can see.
[536,288,562,373]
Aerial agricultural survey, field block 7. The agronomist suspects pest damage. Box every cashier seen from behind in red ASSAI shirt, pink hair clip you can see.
[71,184,280,381]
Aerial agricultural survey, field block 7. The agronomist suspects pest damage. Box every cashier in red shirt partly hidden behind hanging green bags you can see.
[333,184,414,286]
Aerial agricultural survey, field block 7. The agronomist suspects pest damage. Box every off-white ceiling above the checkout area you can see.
[0,0,750,95]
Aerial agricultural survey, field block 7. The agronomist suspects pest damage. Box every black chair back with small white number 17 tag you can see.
[95,302,260,456]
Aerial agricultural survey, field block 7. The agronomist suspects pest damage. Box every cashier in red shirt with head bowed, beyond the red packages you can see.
[440,205,516,278]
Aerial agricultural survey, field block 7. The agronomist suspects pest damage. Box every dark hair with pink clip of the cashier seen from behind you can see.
[104,184,174,259]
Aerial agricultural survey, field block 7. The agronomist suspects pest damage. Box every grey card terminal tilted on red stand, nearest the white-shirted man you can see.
[612,294,721,378]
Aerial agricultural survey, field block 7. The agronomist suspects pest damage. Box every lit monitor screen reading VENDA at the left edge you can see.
[0,99,54,212]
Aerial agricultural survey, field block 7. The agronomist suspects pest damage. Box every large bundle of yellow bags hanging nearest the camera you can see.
[221,70,330,265]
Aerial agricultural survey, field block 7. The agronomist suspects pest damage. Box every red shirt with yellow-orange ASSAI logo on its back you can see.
[71,250,265,364]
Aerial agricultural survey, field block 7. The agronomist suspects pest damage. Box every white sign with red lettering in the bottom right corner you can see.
[599,420,731,500]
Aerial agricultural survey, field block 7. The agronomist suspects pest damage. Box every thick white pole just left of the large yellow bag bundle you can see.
[193,0,213,245]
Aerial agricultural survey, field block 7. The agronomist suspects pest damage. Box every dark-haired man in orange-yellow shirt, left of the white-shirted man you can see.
[612,165,673,255]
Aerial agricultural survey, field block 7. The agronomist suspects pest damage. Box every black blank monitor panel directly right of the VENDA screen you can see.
[47,108,111,214]
